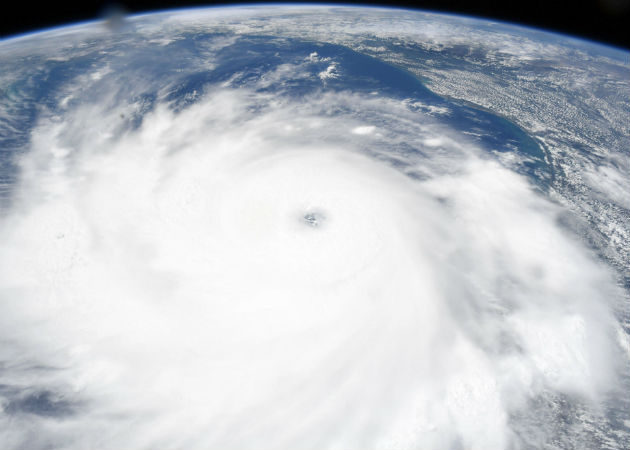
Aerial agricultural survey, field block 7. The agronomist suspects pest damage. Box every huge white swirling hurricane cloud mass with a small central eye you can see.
[0,7,627,449]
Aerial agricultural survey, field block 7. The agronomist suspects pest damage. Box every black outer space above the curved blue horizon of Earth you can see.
[0,0,630,49]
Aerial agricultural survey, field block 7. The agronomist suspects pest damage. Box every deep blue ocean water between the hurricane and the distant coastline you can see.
[0,33,552,202]
